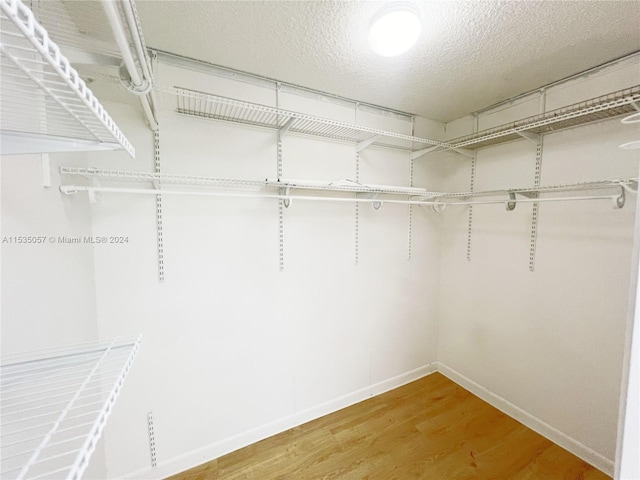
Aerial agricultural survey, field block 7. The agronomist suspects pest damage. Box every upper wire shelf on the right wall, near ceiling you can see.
[449,85,640,148]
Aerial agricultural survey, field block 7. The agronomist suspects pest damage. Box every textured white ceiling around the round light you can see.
[136,0,640,121]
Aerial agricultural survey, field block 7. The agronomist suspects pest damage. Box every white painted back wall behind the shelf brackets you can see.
[85,65,442,478]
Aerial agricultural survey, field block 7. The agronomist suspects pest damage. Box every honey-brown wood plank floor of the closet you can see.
[171,373,610,480]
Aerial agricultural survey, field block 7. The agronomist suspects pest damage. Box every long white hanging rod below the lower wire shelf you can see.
[60,185,622,209]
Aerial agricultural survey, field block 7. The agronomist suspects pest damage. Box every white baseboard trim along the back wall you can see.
[123,363,436,480]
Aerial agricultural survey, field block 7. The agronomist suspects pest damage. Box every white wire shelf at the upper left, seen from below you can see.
[0,0,135,157]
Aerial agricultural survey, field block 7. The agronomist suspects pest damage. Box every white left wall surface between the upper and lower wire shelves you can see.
[0,154,105,478]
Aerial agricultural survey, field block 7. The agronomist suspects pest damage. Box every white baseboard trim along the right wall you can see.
[434,362,614,476]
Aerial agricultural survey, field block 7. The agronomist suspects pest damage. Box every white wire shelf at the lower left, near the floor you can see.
[0,336,142,480]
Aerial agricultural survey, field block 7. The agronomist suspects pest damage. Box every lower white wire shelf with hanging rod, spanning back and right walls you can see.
[60,167,638,210]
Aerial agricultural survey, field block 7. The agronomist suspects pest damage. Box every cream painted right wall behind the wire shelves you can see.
[438,57,638,473]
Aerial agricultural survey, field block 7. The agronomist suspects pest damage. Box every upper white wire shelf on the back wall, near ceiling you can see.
[159,87,449,151]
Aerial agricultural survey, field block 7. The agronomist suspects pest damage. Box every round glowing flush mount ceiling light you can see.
[369,2,422,57]
